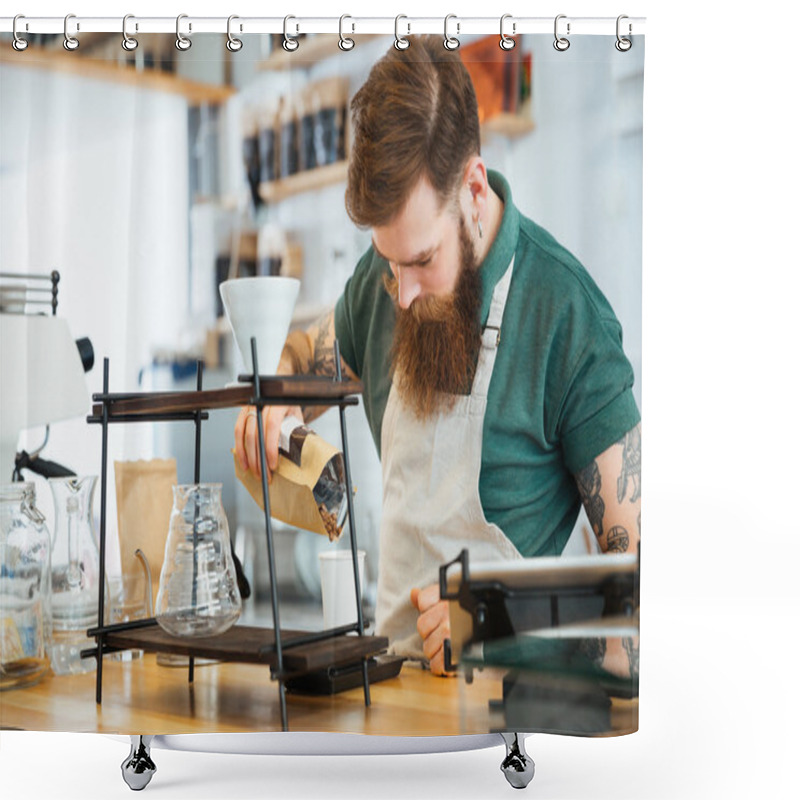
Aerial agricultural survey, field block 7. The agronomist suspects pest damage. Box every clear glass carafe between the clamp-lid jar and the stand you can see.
[49,475,107,675]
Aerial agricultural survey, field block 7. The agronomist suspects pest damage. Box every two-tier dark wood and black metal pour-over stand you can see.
[86,354,374,730]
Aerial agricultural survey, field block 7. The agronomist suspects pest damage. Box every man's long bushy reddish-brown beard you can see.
[384,217,481,420]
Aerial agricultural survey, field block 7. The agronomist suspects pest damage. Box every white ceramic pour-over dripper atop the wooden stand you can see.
[219,275,300,375]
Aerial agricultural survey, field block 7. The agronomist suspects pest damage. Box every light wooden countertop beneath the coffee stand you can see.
[0,654,638,736]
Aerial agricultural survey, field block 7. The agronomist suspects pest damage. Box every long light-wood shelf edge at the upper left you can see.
[0,47,236,106]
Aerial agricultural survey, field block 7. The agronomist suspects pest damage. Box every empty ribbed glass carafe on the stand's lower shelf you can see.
[156,483,242,636]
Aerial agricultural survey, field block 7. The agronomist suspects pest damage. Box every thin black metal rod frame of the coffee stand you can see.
[81,337,371,731]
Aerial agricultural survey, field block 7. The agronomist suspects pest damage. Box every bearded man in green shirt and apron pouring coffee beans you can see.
[235,37,641,674]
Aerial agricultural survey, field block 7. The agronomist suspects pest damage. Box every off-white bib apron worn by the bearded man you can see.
[376,257,522,660]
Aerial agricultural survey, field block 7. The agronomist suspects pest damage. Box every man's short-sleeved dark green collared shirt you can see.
[335,171,640,556]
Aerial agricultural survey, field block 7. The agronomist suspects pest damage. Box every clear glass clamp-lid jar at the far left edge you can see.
[0,483,52,689]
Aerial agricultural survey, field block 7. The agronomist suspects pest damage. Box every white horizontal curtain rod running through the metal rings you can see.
[0,14,645,37]
